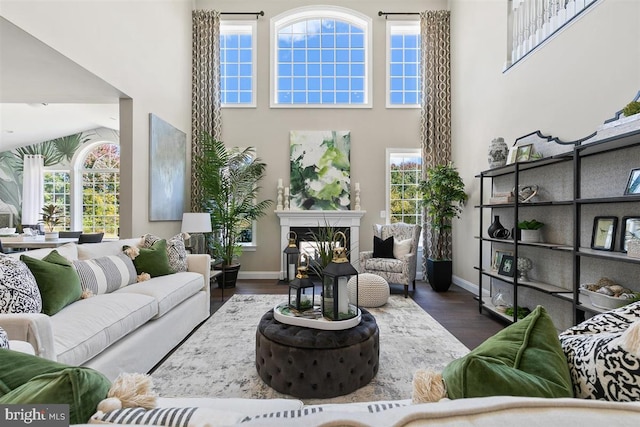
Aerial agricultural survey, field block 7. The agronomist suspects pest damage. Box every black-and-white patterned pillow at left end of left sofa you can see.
[0,254,42,313]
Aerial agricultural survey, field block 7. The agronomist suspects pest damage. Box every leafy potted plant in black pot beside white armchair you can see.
[420,164,468,292]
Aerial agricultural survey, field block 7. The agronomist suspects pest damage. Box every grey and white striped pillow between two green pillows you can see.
[73,253,137,295]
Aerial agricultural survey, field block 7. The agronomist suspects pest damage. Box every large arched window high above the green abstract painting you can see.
[271,6,371,107]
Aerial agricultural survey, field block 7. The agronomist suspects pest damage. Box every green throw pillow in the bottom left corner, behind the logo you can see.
[0,349,111,424]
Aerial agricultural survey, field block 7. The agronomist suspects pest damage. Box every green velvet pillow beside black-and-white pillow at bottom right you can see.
[442,306,573,399]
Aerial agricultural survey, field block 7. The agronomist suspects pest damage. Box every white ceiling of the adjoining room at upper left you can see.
[0,17,126,151]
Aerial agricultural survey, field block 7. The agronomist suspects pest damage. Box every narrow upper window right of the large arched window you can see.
[387,21,422,108]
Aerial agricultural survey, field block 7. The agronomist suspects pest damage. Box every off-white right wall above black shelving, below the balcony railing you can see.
[450,0,640,290]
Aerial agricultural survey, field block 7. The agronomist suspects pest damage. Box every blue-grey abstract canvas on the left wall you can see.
[149,114,187,221]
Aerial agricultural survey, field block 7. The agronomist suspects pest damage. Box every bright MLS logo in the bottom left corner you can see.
[0,405,69,427]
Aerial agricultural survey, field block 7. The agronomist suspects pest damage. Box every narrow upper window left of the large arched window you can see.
[220,21,256,107]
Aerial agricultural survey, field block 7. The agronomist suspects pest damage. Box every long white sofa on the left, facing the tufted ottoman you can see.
[0,238,210,380]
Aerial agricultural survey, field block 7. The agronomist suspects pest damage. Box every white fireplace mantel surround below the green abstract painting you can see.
[275,210,367,279]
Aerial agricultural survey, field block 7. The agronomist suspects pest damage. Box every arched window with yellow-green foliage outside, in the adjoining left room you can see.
[81,143,120,237]
